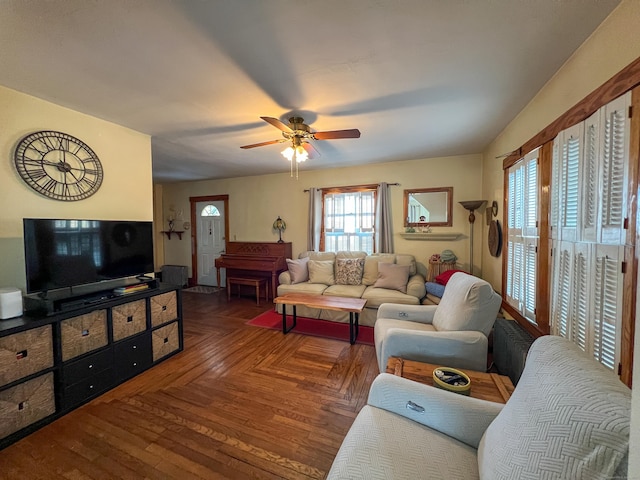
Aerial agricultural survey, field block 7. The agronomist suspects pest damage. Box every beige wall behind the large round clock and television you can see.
[0,87,153,290]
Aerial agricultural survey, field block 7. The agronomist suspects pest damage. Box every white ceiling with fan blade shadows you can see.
[0,0,619,182]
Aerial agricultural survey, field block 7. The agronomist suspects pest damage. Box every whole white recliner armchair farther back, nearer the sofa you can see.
[374,272,502,372]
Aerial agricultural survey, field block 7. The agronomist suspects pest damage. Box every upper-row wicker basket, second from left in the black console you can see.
[60,310,108,362]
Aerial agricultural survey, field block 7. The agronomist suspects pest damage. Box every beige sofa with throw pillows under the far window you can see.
[277,252,426,326]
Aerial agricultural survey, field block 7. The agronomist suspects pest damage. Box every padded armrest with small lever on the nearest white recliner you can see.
[367,373,504,449]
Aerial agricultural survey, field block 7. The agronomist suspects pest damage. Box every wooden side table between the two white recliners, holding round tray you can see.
[387,357,514,403]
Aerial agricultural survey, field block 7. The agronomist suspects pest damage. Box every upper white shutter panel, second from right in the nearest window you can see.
[580,110,602,242]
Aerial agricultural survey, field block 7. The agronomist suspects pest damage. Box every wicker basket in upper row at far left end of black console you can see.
[0,325,53,386]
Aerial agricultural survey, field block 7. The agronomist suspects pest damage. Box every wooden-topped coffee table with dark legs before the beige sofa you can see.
[274,293,367,345]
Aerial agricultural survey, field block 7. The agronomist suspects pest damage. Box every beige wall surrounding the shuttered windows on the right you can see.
[482,0,640,472]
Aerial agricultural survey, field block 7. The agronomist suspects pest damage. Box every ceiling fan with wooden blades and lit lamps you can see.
[240,117,360,161]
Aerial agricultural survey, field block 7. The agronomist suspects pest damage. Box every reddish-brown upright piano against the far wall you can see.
[215,242,291,298]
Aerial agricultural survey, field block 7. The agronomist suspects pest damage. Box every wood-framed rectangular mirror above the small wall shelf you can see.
[404,187,453,227]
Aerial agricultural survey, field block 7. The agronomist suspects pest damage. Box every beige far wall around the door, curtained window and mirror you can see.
[162,153,484,276]
